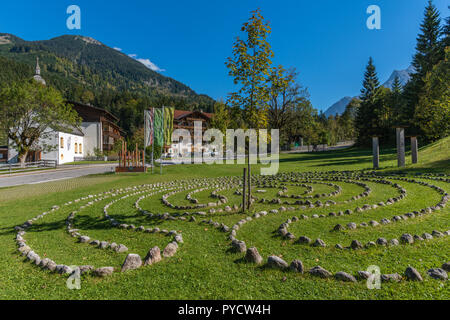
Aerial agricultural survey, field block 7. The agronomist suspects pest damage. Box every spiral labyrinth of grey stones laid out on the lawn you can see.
[15,171,450,282]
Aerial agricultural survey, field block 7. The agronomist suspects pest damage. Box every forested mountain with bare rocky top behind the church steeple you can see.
[0,33,214,106]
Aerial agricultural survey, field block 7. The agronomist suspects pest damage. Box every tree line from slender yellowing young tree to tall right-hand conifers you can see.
[212,0,450,149]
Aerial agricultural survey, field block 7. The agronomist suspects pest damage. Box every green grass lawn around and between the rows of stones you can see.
[0,138,450,300]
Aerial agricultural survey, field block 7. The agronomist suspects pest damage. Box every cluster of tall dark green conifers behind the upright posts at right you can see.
[350,0,450,145]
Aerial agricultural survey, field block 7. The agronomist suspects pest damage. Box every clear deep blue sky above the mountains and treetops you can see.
[0,0,450,110]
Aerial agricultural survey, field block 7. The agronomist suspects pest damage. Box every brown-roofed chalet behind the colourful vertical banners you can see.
[166,110,214,155]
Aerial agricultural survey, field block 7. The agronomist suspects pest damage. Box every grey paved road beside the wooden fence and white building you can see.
[0,164,116,188]
